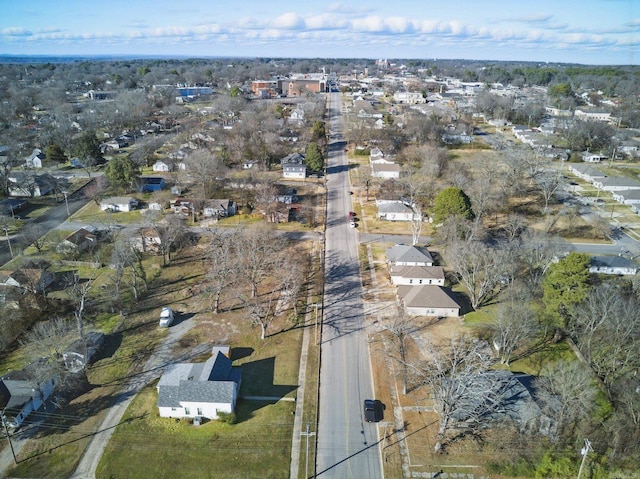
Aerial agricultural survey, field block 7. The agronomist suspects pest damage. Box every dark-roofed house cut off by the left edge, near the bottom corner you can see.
[0,371,58,429]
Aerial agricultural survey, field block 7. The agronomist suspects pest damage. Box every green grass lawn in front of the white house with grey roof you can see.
[96,387,295,478]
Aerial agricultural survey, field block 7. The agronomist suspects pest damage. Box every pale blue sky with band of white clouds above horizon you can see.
[0,0,640,65]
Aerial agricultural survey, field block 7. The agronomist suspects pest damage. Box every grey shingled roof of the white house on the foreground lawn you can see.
[158,351,241,407]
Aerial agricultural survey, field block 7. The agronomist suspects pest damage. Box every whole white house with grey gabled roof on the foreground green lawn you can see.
[157,350,242,419]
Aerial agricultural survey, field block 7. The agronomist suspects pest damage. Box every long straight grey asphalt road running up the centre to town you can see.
[316,93,382,479]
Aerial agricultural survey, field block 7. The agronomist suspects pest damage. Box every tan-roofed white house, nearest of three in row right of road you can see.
[398,285,460,318]
